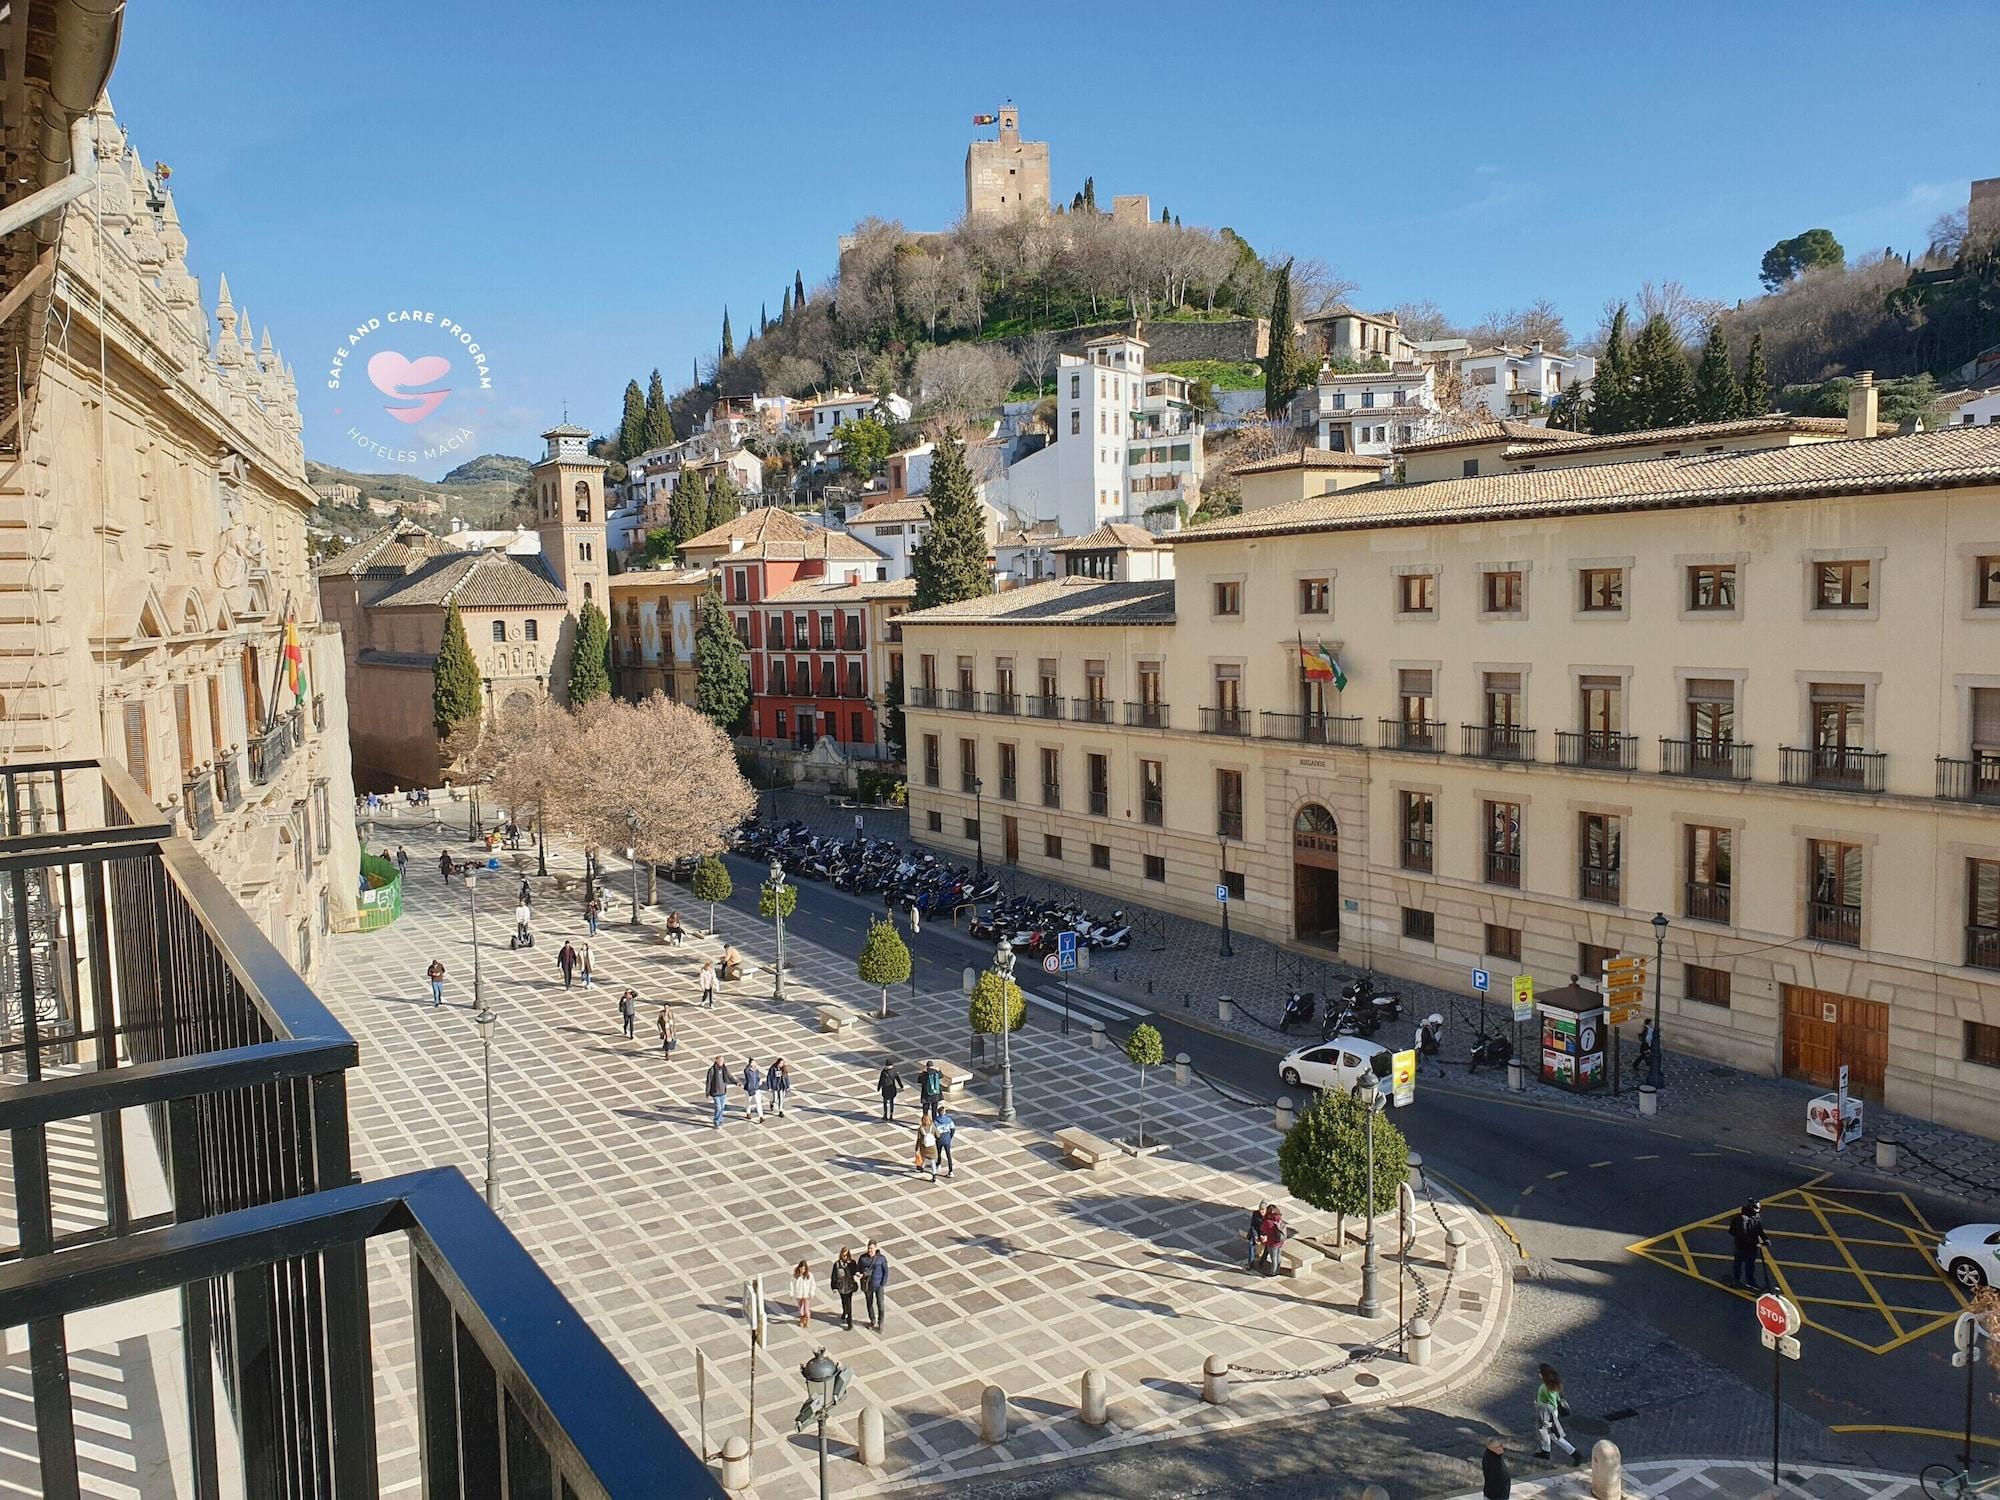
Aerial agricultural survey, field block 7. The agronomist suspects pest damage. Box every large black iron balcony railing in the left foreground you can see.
[0,762,720,1500]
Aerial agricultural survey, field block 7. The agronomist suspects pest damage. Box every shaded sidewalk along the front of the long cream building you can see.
[748,792,2000,1212]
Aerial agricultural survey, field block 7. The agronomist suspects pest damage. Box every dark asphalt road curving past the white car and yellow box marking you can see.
[696,858,2000,1474]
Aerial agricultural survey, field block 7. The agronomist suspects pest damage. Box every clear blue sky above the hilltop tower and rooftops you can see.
[112,0,2000,476]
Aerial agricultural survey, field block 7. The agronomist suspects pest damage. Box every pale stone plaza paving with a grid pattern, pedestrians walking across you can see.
[324,822,1510,1494]
